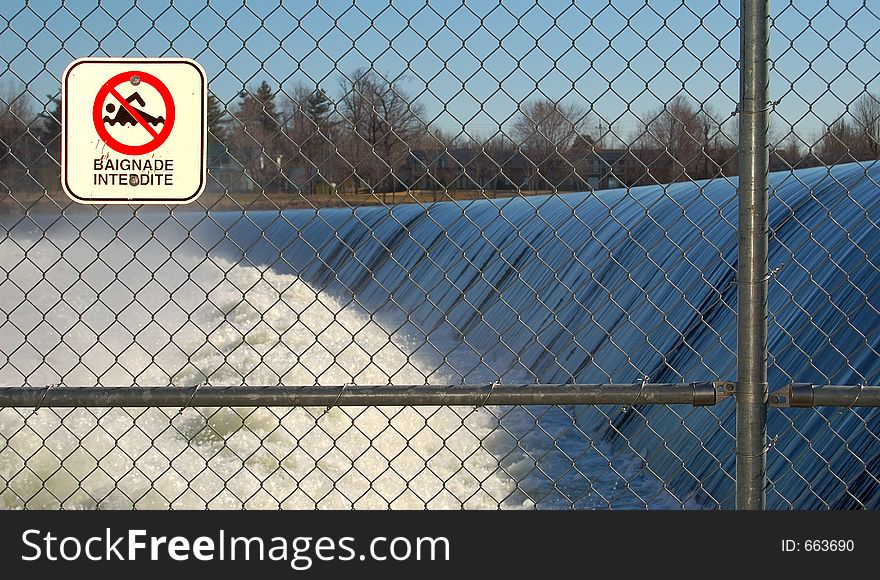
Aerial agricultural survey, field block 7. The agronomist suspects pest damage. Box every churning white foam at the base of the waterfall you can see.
[0,227,534,509]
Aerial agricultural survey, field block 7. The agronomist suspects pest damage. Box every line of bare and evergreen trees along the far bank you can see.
[0,68,880,195]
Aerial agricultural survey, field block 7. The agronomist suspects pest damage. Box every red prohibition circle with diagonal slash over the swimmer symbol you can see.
[92,71,174,155]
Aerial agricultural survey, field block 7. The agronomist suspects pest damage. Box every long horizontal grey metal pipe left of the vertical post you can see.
[0,381,735,408]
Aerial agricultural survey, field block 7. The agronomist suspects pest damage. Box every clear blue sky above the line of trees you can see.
[0,0,880,143]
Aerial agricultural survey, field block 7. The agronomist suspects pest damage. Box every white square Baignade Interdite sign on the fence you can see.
[61,58,208,204]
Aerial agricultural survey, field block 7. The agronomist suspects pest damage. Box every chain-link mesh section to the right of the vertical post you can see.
[768,2,880,509]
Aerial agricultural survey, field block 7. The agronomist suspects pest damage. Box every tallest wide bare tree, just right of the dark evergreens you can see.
[339,69,426,201]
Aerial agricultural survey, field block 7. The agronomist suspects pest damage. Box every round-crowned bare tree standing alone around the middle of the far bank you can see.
[511,98,592,189]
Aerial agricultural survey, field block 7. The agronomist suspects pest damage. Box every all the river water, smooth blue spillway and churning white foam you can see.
[0,164,880,508]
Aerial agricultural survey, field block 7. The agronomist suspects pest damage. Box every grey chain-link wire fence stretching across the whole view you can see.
[0,0,880,509]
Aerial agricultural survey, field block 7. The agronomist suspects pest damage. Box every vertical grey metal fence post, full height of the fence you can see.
[736,0,770,510]
